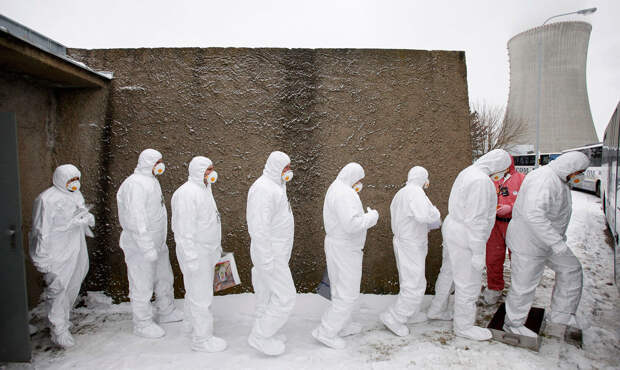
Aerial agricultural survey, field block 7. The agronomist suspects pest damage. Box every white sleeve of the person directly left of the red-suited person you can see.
[464,180,497,255]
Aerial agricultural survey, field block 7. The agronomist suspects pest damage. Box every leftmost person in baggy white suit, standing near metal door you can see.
[29,164,95,347]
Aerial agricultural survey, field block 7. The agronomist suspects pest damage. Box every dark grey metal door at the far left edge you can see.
[0,112,31,362]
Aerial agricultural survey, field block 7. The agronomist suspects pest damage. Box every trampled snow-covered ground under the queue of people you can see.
[27,192,620,369]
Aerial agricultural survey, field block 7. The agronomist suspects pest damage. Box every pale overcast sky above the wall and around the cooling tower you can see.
[0,0,620,138]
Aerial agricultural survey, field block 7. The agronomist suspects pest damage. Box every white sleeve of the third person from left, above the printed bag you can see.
[172,194,200,262]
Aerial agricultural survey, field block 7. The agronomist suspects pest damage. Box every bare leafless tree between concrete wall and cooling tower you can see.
[469,103,527,160]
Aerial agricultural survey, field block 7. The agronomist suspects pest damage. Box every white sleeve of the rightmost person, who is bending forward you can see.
[524,179,564,247]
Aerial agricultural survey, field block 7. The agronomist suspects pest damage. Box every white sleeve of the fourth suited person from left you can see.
[248,188,274,265]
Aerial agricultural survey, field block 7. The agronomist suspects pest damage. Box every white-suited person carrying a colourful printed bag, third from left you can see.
[171,156,226,352]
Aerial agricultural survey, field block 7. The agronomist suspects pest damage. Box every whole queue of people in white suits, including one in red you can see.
[30,149,589,356]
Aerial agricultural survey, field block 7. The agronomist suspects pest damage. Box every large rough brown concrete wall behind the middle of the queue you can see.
[59,48,471,299]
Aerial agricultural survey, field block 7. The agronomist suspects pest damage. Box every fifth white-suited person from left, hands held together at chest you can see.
[312,163,379,349]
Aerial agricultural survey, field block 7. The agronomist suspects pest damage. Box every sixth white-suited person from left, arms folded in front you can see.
[380,166,441,337]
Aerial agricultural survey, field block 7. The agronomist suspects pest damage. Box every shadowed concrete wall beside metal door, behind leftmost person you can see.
[0,72,107,306]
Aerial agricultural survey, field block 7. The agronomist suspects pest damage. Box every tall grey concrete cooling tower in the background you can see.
[506,22,598,153]
